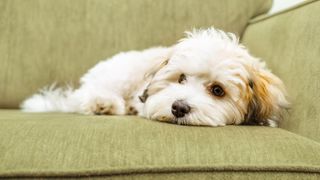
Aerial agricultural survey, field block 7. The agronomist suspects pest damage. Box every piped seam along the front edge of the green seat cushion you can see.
[0,166,320,178]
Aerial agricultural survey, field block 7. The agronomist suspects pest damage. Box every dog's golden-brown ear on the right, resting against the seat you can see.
[244,69,289,126]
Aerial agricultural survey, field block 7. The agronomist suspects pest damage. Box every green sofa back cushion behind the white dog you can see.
[0,0,271,108]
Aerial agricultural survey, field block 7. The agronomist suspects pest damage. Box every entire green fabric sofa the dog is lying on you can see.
[0,0,320,180]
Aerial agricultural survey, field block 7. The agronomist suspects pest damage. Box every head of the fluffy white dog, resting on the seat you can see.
[141,28,288,126]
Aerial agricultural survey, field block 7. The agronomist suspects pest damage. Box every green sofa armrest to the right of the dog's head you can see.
[243,1,320,142]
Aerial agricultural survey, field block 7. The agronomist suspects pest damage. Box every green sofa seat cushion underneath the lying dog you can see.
[0,110,320,179]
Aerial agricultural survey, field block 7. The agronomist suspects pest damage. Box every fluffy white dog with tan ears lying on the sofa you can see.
[21,28,288,126]
